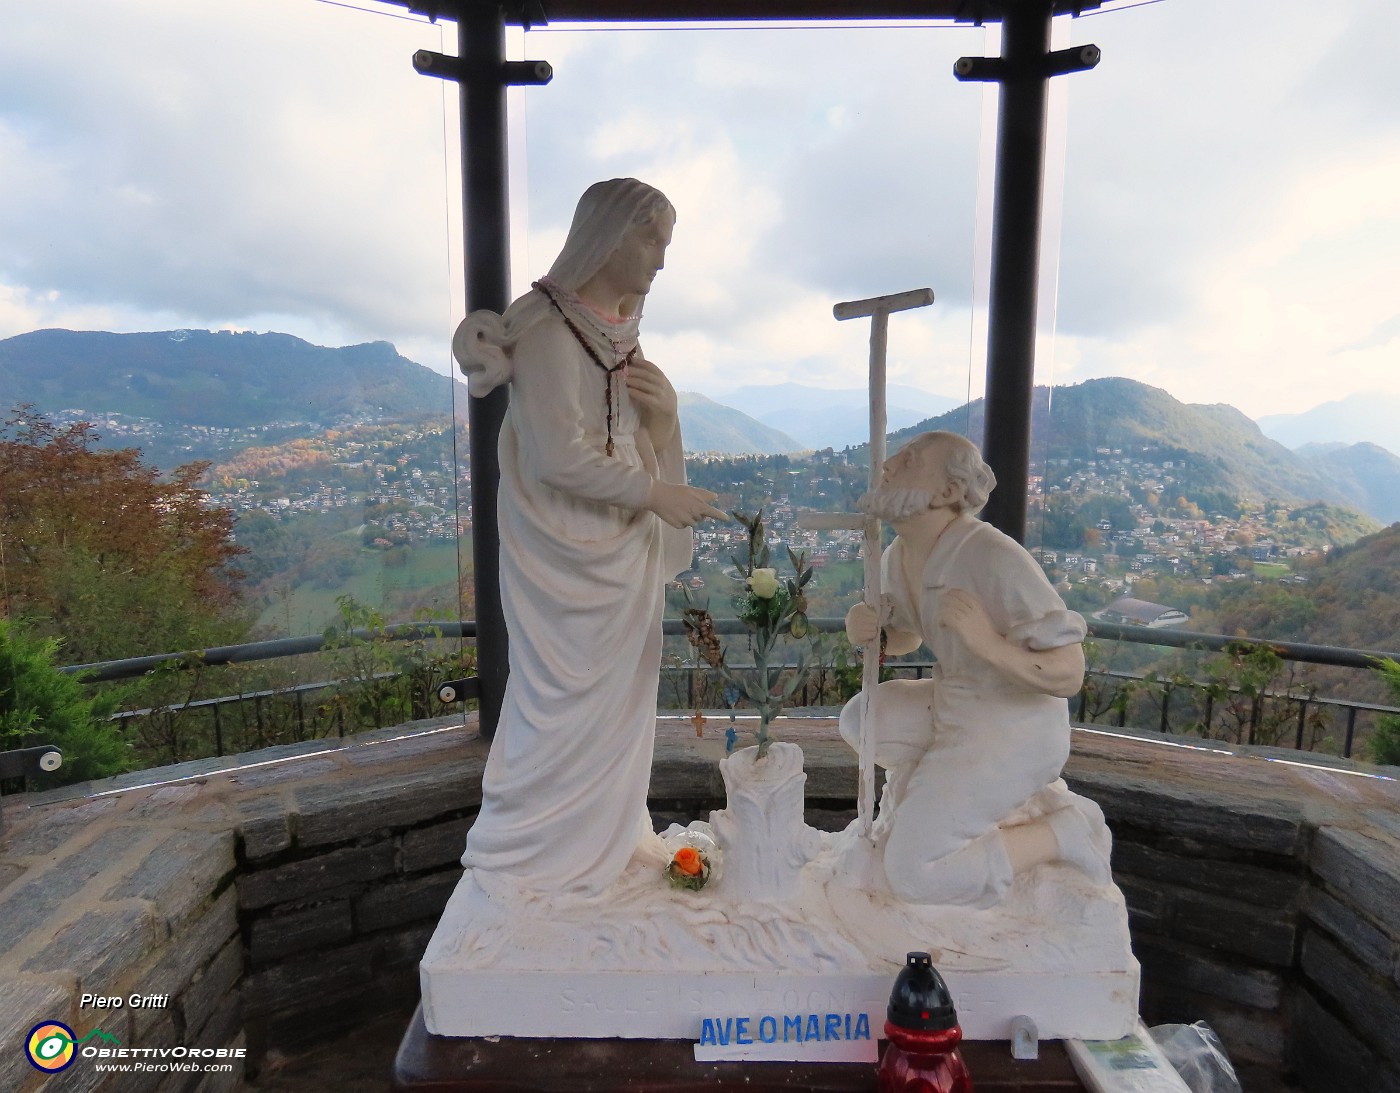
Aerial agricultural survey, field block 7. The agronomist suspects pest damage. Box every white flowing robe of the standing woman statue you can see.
[462,313,693,893]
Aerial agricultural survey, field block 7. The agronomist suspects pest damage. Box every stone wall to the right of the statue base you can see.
[1067,733,1400,1093]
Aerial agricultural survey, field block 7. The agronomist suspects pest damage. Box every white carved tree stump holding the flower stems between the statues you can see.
[710,743,822,901]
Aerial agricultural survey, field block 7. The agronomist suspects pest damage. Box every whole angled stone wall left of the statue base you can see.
[0,718,486,1093]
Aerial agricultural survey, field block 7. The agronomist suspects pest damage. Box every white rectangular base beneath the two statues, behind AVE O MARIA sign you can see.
[421,817,1138,1040]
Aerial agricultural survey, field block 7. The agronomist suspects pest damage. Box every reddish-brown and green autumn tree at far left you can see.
[0,407,246,663]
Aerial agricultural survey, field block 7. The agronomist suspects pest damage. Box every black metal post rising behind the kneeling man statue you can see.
[981,0,1053,543]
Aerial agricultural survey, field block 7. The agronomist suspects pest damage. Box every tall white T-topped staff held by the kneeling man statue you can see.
[832,288,934,838]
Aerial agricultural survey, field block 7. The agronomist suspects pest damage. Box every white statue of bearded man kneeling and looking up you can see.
[841,432,1112,907]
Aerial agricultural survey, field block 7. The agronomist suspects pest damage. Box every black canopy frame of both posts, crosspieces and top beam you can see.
[386,0,1110,735]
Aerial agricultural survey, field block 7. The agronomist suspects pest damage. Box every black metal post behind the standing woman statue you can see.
[456,3,511,736]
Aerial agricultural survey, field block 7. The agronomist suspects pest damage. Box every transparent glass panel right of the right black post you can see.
[1052,3,1400,752]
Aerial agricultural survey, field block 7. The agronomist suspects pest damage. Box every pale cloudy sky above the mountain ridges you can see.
[0,0,1400,416]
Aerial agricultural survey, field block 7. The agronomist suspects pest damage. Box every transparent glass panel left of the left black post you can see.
[0,0,470,775]
